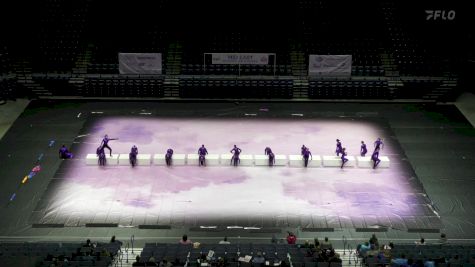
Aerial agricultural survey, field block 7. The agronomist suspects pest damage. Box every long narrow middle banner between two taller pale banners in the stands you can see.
[211,53,273,65]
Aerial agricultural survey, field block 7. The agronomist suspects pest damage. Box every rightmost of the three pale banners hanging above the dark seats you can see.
[308,55,351,76]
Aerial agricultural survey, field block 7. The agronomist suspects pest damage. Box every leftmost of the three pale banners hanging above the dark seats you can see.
[119,53,162,74]
